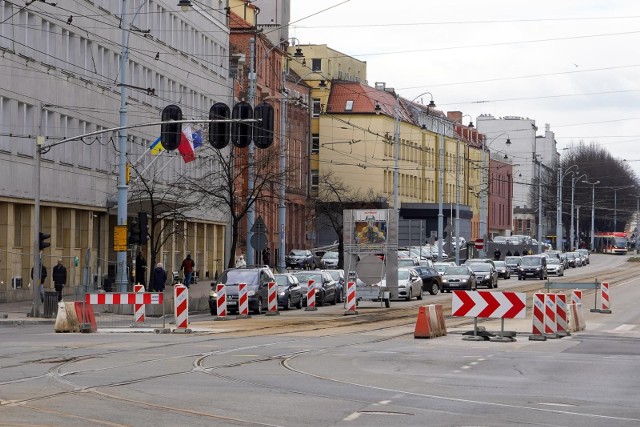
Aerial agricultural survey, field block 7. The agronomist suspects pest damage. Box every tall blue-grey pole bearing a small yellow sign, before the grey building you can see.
[116,0,129,292]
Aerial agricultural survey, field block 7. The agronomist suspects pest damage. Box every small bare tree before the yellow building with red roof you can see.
[315,171,386,268]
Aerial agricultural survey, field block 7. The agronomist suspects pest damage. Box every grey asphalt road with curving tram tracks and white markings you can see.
[0,255,640,426]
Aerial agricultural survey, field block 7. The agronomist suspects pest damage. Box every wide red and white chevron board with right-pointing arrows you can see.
[451,291,527,319]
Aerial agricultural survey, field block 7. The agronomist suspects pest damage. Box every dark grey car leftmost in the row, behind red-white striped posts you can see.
[218,266,276,314]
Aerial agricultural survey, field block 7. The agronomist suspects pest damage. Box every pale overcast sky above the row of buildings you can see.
[289,0,640,177]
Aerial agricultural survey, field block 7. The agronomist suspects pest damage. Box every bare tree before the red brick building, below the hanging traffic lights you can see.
[179,146,281,267]
